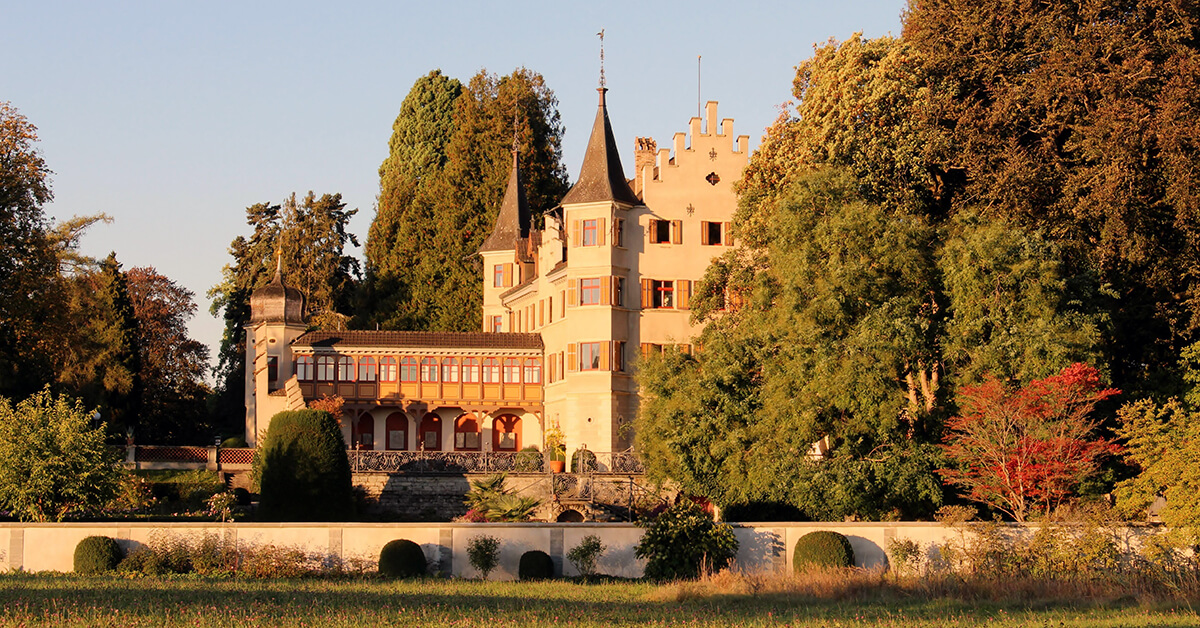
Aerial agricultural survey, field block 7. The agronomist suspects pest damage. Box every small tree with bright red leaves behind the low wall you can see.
[938,364,1121,521]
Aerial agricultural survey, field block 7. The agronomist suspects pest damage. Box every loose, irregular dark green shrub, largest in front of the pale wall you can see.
[634,500,738,580]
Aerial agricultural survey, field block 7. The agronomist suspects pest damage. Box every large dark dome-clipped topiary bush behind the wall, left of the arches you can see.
[253,409,354,521]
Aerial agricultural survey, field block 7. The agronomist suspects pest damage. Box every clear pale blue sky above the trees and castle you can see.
[7,0,905,374]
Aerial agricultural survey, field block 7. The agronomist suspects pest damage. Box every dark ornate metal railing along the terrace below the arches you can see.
[347,450,644,474]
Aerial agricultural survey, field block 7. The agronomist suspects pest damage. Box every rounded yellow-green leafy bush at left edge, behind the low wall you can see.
[0,387,124,521]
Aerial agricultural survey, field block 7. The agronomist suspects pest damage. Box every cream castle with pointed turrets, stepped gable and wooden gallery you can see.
[246,88,750,461]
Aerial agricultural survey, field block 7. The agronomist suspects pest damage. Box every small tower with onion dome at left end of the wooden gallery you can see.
[245,262,307,447]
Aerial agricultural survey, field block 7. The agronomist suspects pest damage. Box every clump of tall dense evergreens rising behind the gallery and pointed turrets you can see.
[360,68,568,331]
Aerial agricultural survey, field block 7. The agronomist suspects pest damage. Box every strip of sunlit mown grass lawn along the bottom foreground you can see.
[0,574,1200,628]
